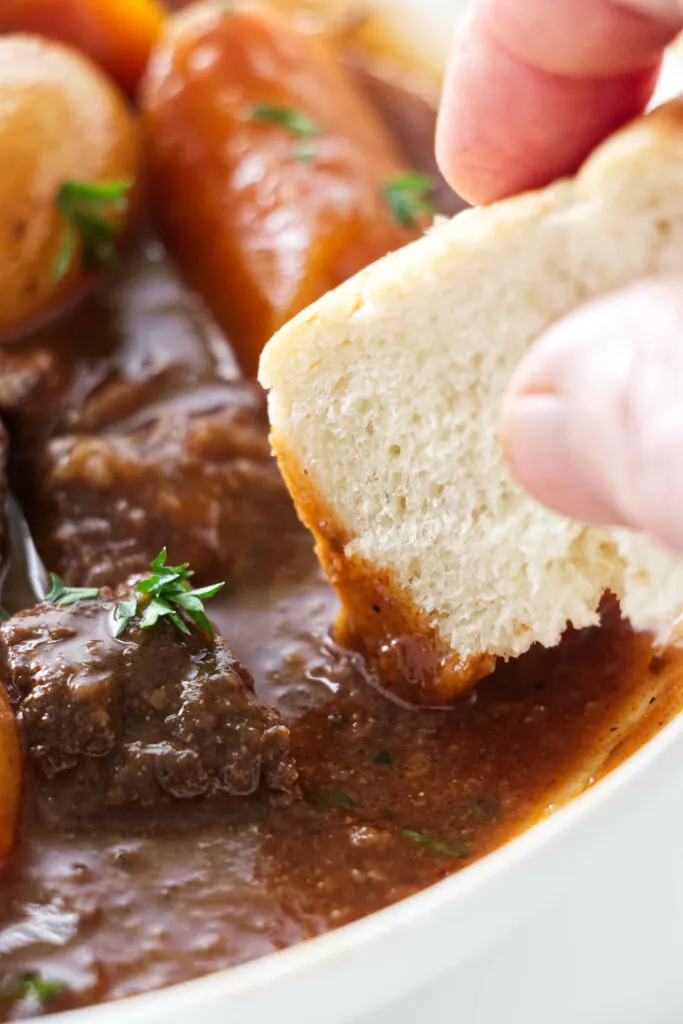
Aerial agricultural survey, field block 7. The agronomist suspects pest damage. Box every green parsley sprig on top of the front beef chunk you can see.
[114,548,224,637]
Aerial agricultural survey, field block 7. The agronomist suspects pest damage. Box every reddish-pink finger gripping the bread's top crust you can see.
[436,0,683,203]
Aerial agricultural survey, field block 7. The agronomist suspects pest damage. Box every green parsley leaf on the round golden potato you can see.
[52,180,133,282]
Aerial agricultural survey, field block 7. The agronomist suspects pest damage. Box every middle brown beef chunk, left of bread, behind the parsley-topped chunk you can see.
[29,383,302,586]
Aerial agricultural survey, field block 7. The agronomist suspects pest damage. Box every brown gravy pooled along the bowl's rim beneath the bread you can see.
[0,489,683,1010]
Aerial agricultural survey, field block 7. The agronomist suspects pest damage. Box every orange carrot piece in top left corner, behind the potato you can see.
[0,0,165,96]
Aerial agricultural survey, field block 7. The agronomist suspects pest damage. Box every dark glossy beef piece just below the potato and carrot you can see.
[0,246,237,448]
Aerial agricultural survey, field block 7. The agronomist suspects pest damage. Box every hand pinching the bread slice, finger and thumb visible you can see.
[437,0,683,553]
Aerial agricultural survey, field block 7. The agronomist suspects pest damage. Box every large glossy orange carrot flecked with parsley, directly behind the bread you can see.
[140,4,417,375]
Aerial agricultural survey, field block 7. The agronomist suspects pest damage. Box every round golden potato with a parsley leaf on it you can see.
[0,35,139,340]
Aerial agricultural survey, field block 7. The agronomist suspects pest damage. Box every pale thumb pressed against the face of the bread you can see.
[501,278,683,553]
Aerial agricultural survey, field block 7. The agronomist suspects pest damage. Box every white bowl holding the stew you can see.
[59,6,683,1024]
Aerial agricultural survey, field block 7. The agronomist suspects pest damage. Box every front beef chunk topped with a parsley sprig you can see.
[0,591,297,817]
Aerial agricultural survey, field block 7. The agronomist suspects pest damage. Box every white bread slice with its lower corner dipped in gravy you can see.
[260,101,683,701]
